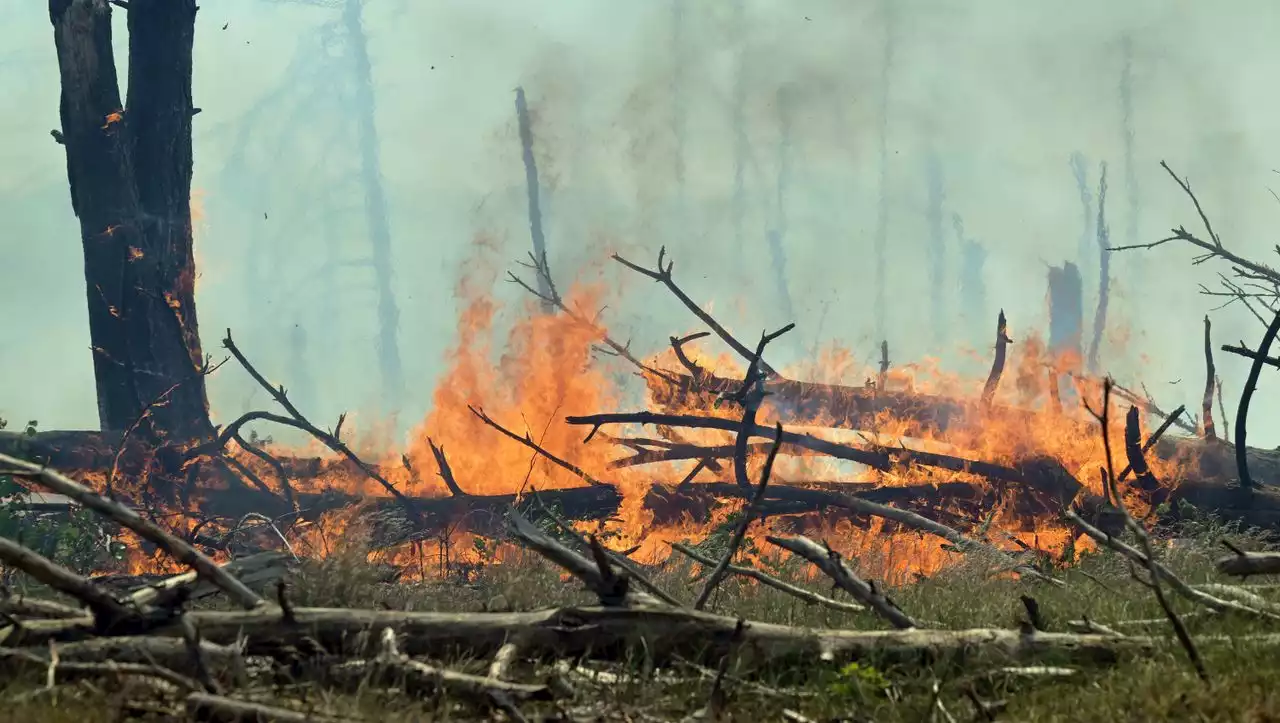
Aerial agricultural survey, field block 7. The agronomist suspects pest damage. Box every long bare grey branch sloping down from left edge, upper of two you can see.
[0,454,262,608]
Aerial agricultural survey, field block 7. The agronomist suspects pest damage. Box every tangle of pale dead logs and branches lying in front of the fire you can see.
[0,435,1280,720]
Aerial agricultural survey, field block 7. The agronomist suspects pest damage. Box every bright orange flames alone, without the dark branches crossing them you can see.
[77,267,1179,582]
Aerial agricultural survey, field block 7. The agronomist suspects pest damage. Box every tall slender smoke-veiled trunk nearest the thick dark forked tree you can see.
[343,0,404,412]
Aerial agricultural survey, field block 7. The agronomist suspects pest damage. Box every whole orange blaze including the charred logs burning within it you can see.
[72,245,1208,582]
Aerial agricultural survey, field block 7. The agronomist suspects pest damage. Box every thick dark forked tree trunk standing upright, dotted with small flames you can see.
[49,0,212,439]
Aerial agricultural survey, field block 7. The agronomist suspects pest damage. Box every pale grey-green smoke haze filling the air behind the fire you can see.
[0,0,1280,445]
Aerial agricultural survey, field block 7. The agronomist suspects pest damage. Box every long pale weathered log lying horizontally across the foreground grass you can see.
[0,607,1157,668]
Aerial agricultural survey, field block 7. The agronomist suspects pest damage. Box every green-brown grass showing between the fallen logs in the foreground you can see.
[0,511,1280,723]
